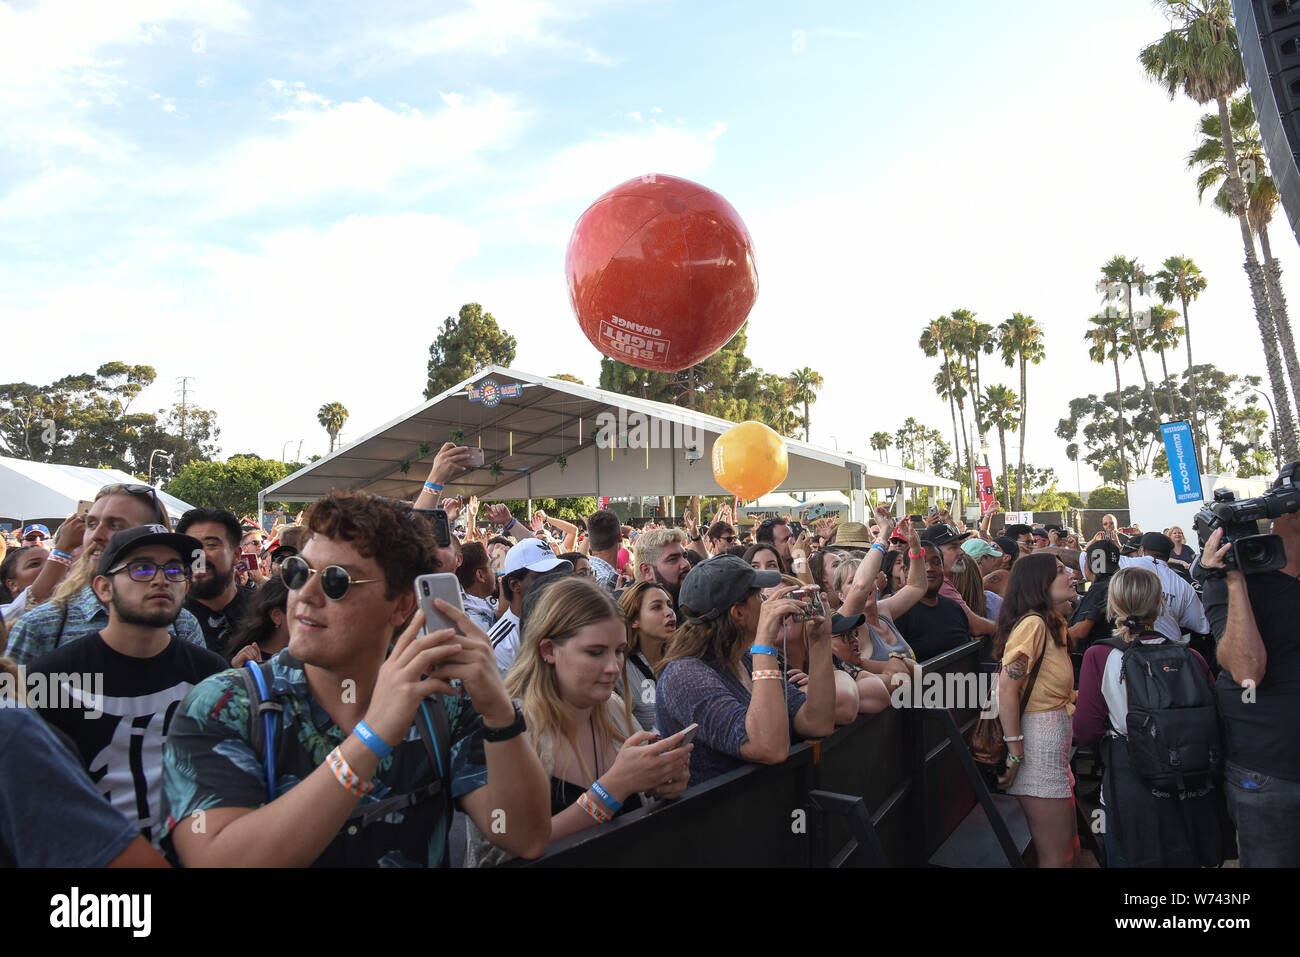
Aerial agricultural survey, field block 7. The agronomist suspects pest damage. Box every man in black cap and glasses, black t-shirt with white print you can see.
[27,525,226,846]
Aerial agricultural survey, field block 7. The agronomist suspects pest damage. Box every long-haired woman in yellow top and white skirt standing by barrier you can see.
[995,554,1079,867]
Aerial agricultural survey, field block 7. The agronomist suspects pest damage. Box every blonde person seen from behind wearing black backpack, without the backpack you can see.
[1074,566,1223,867]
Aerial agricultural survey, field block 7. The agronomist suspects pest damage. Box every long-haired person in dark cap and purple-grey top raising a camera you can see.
[655,555,836,784]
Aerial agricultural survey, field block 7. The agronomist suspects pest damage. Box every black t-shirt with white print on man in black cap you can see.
[27,632,228,846]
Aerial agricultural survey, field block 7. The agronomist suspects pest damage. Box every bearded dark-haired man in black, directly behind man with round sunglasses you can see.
[176,508,256,661]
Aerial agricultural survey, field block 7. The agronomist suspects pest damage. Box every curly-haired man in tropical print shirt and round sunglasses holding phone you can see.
[164,492,550,867]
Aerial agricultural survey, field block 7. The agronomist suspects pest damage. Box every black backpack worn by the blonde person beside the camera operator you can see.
[1097,633,1223,793]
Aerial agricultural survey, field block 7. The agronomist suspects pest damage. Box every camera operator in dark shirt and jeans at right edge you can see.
[1200,512,1300,867]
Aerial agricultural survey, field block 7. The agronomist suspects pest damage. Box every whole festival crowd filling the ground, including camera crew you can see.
[0,442,1300,866]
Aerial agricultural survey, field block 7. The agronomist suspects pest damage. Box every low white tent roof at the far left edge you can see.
[0,456,191,525]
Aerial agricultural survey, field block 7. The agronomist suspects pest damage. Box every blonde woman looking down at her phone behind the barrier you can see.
[465,576,692,867]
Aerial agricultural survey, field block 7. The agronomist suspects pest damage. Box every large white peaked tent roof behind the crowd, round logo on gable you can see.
[259,365,958,516]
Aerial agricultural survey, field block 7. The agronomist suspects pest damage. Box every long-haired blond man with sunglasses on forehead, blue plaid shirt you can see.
[5,485,205,664]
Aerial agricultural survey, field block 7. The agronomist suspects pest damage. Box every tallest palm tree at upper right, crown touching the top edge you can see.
[1138,0,1300,460]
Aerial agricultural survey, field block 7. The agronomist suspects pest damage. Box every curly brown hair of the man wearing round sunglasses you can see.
[302,490,439,601]
